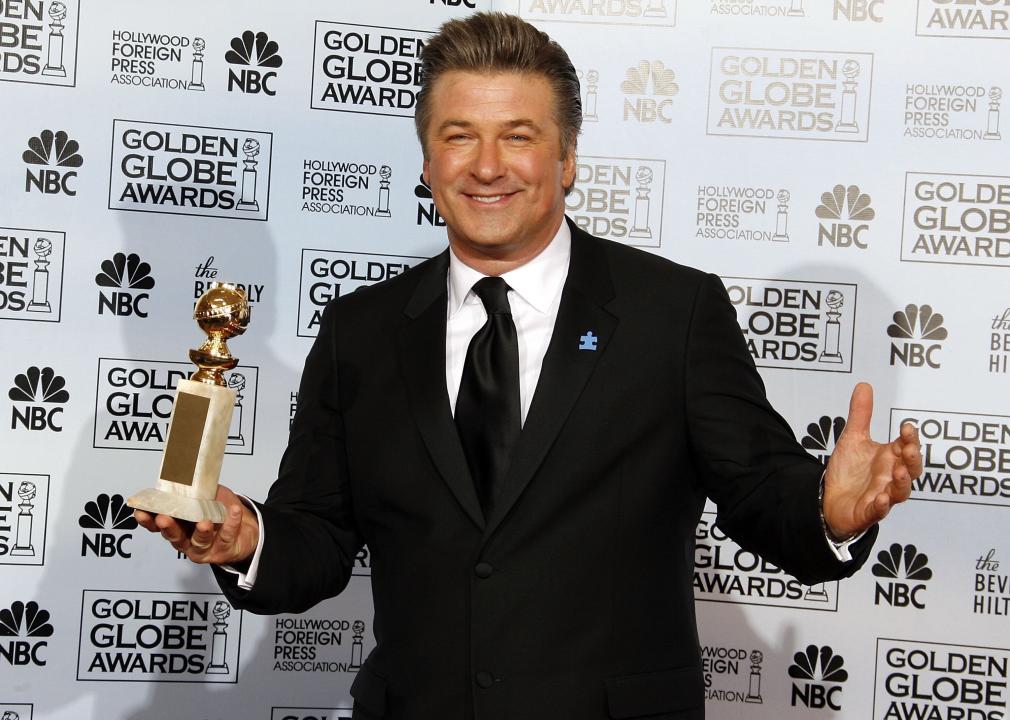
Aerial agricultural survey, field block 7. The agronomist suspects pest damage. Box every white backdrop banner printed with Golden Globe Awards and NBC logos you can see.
[0,0,1010,720]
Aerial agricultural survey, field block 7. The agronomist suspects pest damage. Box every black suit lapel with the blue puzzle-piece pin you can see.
[484,222,617,538]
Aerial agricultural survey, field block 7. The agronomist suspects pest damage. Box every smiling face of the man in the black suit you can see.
[424,72,575,265]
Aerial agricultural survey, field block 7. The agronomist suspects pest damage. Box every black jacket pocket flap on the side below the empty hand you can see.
[605,665,705,720]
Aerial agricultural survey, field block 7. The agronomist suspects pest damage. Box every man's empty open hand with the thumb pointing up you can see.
[822,383,922,539]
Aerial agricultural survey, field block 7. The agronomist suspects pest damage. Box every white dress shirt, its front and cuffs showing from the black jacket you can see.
[223,221,863,590]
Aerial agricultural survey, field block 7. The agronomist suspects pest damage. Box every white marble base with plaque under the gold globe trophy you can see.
[126,380,235,523]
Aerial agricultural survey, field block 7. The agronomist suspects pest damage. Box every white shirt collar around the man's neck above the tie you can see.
[448,219,572,317]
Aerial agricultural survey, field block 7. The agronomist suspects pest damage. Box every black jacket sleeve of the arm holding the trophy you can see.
[214,302,363,613]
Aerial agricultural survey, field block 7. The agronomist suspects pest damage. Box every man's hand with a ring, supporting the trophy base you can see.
[133,485,260,565]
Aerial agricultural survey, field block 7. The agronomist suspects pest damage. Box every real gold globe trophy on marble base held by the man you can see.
[126,283,249,523]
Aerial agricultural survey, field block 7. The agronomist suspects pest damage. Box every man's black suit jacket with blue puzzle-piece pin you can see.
[218,226,874,720]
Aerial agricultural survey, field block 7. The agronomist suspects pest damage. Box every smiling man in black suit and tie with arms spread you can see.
[137,13,921,720]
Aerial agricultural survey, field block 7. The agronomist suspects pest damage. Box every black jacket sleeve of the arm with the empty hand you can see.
[685,275,877,585]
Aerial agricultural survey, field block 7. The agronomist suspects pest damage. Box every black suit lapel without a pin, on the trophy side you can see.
[398,250,484,528]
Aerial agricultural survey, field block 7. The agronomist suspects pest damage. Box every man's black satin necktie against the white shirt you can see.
[456,278,521,517]
